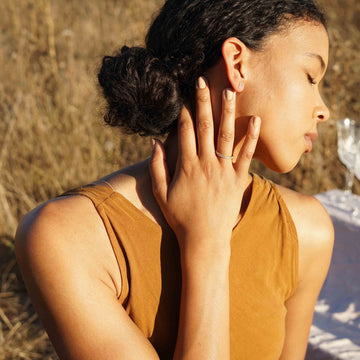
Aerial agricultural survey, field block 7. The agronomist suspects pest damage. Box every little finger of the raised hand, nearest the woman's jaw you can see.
[235,116,261,175]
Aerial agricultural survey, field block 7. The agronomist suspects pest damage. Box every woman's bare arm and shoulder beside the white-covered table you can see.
[281,189,334,360]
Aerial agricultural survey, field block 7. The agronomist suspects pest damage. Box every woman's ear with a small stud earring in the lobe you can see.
[221,37,249,92]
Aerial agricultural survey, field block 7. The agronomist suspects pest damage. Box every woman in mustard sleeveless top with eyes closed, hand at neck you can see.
[16,0,333,360]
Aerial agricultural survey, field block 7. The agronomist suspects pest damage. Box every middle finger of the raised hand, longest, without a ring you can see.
[196,76,215,157]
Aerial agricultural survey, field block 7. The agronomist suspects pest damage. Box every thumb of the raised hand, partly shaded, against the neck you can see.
[149,139,169,207]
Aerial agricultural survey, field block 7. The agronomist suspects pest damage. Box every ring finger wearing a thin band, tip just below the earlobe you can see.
[216,89,235,164]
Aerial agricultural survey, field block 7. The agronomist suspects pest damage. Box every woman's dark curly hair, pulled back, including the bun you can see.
[98,0,326,135]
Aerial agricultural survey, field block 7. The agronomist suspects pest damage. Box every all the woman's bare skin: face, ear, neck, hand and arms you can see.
[16,22,333,360]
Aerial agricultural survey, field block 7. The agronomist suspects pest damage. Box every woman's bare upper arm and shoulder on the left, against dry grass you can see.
[16,196,158,360]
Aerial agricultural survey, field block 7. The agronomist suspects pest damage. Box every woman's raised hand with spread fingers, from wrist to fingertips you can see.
[150,78,260,252]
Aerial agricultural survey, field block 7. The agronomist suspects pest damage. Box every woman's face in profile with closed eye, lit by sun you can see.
[237,21,329,173]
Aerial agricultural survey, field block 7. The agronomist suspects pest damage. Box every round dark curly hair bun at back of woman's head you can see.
[98,46,183,135]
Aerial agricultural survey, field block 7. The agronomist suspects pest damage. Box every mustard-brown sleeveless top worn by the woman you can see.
[64,174,298,360]
